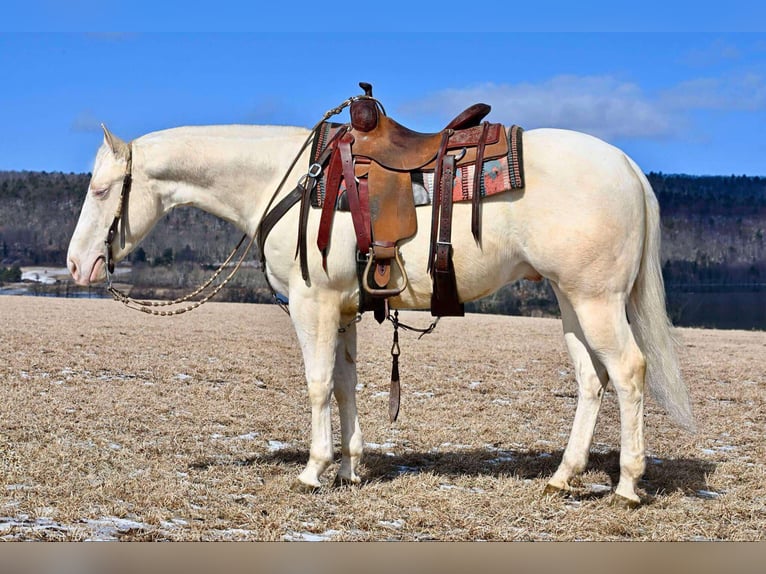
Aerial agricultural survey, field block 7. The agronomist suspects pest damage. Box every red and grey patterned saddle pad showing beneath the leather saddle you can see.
[311,122,524,209]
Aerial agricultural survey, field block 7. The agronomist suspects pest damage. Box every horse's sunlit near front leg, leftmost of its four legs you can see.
[290,287,340,490]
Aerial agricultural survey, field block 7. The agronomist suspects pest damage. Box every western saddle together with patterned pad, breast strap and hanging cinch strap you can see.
[258,82,524,422]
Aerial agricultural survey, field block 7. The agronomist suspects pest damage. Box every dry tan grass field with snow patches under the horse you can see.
[0,296,766,541]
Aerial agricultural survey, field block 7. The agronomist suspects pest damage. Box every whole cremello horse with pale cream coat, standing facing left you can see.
[68,122,693,506]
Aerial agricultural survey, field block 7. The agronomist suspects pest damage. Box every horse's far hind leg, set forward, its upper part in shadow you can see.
[545,286,609,494]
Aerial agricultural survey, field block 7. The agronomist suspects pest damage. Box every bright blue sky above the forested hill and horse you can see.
[0,6,766,176]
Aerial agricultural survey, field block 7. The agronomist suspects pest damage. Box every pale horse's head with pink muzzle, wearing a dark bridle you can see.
[67,125,156,285]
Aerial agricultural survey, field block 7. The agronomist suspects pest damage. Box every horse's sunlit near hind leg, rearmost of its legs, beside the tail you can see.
[560,294,646,506]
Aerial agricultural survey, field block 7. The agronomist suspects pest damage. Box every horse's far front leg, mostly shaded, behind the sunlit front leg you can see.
[333,317,364,484]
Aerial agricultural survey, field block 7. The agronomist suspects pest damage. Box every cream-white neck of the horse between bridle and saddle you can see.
[134,126,307,234]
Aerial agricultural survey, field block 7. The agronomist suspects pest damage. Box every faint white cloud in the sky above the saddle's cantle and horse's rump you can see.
[398,74,766,140]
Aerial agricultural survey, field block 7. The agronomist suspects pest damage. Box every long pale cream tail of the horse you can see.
[628,158,695,431]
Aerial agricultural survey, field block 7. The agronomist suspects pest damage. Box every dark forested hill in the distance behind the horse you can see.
[0,172,766,288]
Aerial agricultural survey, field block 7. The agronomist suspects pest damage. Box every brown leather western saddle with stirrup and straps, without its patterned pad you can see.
[317,82,508,316]
